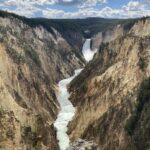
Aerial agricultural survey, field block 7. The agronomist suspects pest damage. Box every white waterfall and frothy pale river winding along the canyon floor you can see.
[54,39,95,150]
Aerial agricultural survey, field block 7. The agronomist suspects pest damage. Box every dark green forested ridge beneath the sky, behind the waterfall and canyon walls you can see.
[0,10,145,36]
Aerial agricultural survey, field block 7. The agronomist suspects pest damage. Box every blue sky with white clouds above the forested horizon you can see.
[0,0,150,18]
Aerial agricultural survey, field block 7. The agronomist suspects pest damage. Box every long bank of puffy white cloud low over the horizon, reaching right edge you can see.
[42,1,150,18]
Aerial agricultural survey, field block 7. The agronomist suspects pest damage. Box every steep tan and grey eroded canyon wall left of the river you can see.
[0,16,84,150]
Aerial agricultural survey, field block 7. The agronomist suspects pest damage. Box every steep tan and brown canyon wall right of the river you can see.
[68,19,150,150]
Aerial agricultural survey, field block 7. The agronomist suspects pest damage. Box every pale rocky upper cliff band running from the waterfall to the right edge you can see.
[92,17,149,50]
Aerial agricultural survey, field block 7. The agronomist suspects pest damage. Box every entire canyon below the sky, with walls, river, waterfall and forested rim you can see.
[0,11,150,150]
